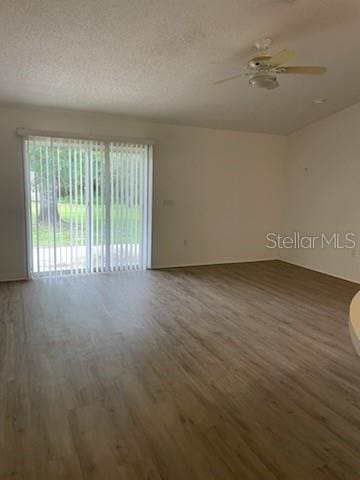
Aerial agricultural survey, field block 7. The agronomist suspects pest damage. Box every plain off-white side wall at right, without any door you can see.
[281,100,360,282]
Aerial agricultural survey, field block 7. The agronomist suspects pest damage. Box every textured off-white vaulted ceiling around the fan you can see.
[0,0,360,134]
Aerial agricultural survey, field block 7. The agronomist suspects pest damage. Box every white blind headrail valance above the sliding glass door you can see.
[16,128,155,145]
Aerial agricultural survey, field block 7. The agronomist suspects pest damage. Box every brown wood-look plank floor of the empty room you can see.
[0,262,360,480]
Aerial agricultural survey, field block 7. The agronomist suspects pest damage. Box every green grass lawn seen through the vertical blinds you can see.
[32,202,141,247]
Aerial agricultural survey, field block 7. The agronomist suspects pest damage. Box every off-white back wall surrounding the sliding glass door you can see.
[0,106,285,279]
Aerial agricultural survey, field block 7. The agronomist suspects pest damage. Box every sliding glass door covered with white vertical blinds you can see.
[25,137,151,276]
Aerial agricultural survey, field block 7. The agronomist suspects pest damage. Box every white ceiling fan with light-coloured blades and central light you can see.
[212,38,327,90]
